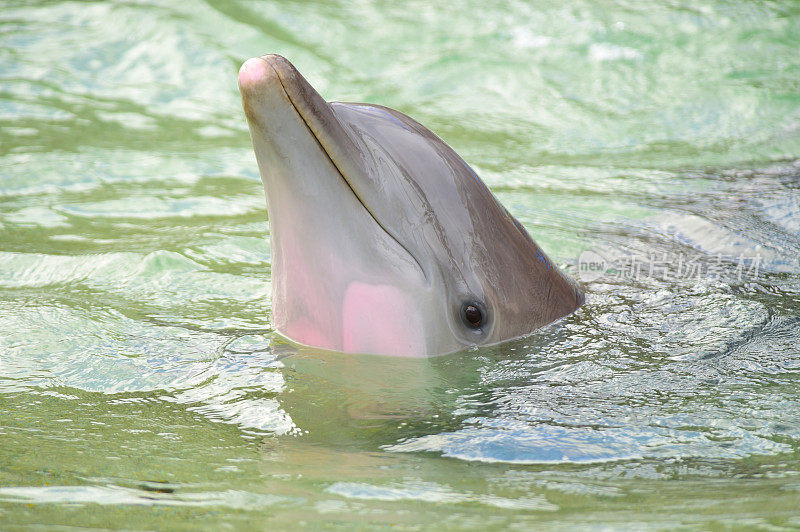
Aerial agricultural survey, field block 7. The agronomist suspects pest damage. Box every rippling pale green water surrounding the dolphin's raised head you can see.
[0,1,800,530]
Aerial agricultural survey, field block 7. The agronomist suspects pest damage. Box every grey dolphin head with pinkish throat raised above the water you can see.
[239,55,583,356]
